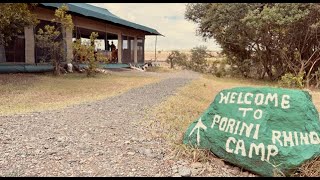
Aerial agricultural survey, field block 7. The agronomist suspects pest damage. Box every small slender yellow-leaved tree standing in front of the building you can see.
[35,4,73,75]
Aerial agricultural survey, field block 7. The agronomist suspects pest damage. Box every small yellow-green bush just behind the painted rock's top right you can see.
[279,73,304,88]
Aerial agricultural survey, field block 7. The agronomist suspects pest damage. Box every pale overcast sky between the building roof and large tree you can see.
[90,3,220,51]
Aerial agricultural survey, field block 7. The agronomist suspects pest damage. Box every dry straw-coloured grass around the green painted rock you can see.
[149,75,320,176]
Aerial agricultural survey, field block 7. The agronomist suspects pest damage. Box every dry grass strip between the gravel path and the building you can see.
[0,73,160,115]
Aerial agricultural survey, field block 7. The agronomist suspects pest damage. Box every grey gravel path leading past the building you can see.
[0,69,197,176]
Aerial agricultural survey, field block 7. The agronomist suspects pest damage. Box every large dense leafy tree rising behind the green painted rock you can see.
[185,3,320,86]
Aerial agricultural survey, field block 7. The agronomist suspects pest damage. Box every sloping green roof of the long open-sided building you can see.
[40,3,161,35]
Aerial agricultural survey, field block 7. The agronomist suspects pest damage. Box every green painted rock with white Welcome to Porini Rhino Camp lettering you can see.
[183,87,320,176]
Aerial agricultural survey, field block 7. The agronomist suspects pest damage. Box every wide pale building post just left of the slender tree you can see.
[24,26,35,64]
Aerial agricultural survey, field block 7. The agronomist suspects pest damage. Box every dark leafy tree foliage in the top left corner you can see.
[0,3,37,45]
